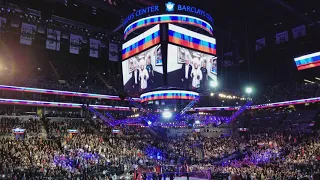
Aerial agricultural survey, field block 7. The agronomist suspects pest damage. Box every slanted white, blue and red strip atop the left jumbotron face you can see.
[122,25,160,60]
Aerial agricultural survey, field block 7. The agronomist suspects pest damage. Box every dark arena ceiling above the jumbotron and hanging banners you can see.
[4,0,320,36]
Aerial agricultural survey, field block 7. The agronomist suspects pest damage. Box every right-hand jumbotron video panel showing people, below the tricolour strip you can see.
[167,44,217,90]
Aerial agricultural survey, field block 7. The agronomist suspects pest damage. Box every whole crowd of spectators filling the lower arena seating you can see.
[0,104,320,179]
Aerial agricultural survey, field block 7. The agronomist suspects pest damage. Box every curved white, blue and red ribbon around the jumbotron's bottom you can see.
[140,90,199,102]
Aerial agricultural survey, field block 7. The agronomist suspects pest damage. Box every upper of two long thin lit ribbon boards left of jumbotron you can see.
[0,85,140,101]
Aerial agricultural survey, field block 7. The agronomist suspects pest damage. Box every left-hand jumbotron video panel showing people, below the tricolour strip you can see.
[122,45,164,94]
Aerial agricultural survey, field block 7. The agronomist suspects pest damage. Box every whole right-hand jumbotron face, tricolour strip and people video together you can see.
[167,24,217,89]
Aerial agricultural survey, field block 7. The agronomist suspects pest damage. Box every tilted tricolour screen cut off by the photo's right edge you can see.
[294,52,320,70]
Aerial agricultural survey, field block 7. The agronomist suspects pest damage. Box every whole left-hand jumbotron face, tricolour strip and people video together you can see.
[122,25,163,93]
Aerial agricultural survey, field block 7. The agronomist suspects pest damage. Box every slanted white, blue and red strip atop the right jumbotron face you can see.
[168,24,216,55]
